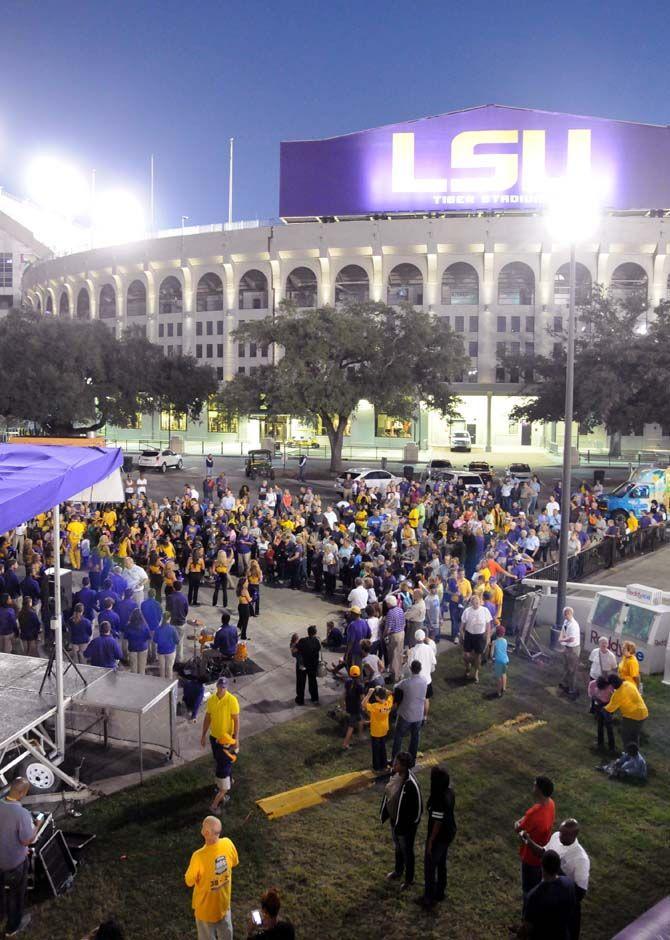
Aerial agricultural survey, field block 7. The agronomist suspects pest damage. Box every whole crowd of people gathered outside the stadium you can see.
[0,464,664,940]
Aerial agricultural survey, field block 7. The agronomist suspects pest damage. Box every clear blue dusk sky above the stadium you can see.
[0,0,670,227]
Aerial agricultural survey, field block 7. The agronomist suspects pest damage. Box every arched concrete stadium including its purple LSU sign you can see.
[7,105,670,453]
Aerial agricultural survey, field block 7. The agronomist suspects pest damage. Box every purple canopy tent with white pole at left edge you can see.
[0,444,123,759]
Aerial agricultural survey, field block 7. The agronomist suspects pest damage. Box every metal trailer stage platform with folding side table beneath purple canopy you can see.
[0,653,177,789]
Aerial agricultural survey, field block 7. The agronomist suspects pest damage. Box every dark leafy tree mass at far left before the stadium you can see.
[0,309,217,434]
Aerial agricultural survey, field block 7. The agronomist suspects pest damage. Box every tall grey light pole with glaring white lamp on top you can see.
[546,176,601,647]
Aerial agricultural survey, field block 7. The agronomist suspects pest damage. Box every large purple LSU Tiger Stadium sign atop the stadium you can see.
[279,105,670,218]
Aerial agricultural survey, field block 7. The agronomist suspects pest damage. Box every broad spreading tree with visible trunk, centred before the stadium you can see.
[220,301,469,470]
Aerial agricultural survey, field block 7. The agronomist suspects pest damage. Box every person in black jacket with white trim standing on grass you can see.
[380,751,423,888]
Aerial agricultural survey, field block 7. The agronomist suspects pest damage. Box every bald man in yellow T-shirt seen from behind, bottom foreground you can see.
[184,816,239,940]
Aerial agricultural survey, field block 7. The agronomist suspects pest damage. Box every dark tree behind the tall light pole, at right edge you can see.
[504,288,670,454]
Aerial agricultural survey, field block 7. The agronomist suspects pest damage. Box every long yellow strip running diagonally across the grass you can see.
[256,712,546,819]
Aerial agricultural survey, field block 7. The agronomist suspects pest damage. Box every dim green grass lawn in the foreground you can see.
[30,654,670,940]
